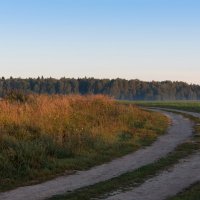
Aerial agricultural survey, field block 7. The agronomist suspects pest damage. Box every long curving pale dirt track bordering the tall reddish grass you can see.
[0,111,193,200]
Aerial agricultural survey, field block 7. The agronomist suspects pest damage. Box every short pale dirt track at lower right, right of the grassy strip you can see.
[106,154,200,200]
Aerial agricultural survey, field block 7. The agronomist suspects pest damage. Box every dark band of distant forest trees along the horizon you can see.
[0,77,200,100]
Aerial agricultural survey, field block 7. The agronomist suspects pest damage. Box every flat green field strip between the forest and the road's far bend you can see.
[122,101,200,113]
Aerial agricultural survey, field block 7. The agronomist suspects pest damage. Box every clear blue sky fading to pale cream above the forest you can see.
[0,0,200,84]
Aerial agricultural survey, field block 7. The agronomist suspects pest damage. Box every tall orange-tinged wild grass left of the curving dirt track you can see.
[0,95,168,191]
